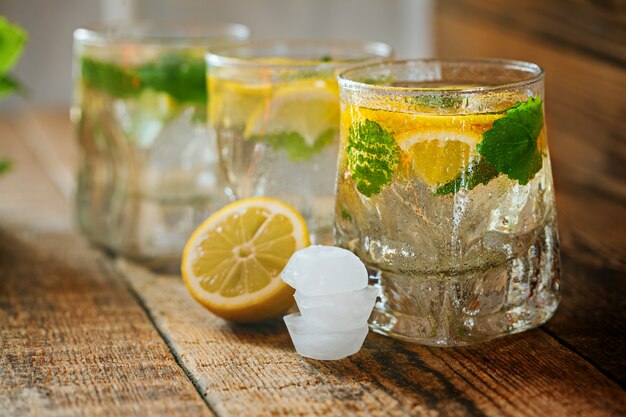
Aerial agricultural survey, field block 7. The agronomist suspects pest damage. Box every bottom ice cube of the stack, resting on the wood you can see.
[283,313,368,361]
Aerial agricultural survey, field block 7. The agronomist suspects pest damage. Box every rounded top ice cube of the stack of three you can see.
[281,245,368,296]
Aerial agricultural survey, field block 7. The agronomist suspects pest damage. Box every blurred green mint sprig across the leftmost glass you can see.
[81,52,207,104]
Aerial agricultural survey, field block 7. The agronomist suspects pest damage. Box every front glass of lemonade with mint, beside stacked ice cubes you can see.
[335,60,560,346]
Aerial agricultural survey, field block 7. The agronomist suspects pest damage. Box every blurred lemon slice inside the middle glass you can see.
[244,80,339,146]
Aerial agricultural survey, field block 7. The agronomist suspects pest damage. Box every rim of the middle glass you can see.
[205,39,395,70]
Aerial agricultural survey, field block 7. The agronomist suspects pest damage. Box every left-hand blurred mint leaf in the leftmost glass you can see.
[81,57,142,98]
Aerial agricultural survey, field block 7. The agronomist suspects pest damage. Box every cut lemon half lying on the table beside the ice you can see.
[181,197,309,322]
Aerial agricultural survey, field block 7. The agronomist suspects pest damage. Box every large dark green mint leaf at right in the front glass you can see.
[476,97,543,185]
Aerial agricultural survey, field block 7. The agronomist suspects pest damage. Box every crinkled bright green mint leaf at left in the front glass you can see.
[347,120,400,197]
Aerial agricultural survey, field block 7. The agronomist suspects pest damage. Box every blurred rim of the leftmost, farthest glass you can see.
[74,20,250,45]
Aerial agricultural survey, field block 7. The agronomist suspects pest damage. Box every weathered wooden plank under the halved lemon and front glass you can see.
[118,261,626,416]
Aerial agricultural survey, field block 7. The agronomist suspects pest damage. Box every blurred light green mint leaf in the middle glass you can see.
[249,128,335,162]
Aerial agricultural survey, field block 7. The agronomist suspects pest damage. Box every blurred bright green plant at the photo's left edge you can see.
[0,16,28,173]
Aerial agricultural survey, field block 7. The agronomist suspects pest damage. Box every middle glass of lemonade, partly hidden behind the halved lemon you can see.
[207,40,392,244]
